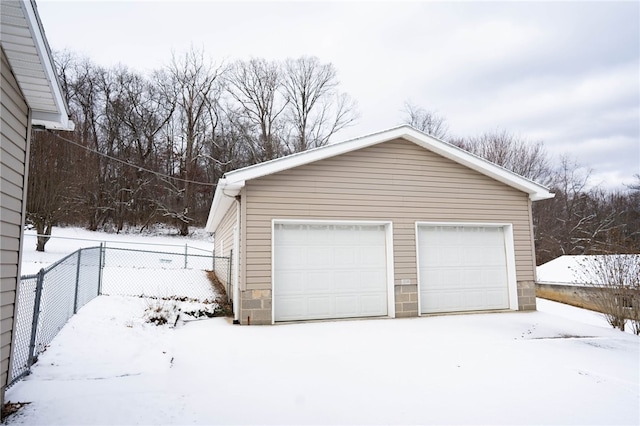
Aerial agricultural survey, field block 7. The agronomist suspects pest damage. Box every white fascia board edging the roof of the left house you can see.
[21,0,75,131]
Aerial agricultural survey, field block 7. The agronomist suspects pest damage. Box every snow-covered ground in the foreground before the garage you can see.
[7,296,640,425]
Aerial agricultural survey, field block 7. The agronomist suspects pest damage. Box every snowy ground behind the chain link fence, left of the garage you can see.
[21,227,215,300]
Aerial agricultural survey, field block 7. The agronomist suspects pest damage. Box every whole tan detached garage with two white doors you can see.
[207,126,553,324]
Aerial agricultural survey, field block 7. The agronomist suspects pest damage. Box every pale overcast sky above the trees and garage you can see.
[37,0,640,188]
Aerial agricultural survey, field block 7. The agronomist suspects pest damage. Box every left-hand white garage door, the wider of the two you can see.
[273,224,388,321]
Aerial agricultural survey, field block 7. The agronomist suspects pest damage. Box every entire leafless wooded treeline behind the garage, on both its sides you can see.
[27,50,640,264]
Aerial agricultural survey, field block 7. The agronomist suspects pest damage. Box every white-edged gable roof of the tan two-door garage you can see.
[206,125,554,232]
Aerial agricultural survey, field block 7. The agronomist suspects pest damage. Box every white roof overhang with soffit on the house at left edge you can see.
[0,0,74,130]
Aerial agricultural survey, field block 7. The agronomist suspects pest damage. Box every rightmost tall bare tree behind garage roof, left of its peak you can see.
[283,56,357,152]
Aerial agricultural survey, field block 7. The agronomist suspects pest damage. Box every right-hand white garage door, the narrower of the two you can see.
[418,225,509,313]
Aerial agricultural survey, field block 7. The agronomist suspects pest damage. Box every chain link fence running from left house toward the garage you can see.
[9,244,231,386]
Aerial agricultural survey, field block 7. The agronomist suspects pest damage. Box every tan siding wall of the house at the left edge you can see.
[0,49,29,402]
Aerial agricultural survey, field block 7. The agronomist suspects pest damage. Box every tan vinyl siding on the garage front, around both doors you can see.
[243,140,534,289]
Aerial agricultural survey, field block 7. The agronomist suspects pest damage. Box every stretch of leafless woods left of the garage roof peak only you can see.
[27,50,357,248]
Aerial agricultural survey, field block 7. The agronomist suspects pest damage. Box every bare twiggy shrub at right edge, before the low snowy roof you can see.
[576,254,640,335]
